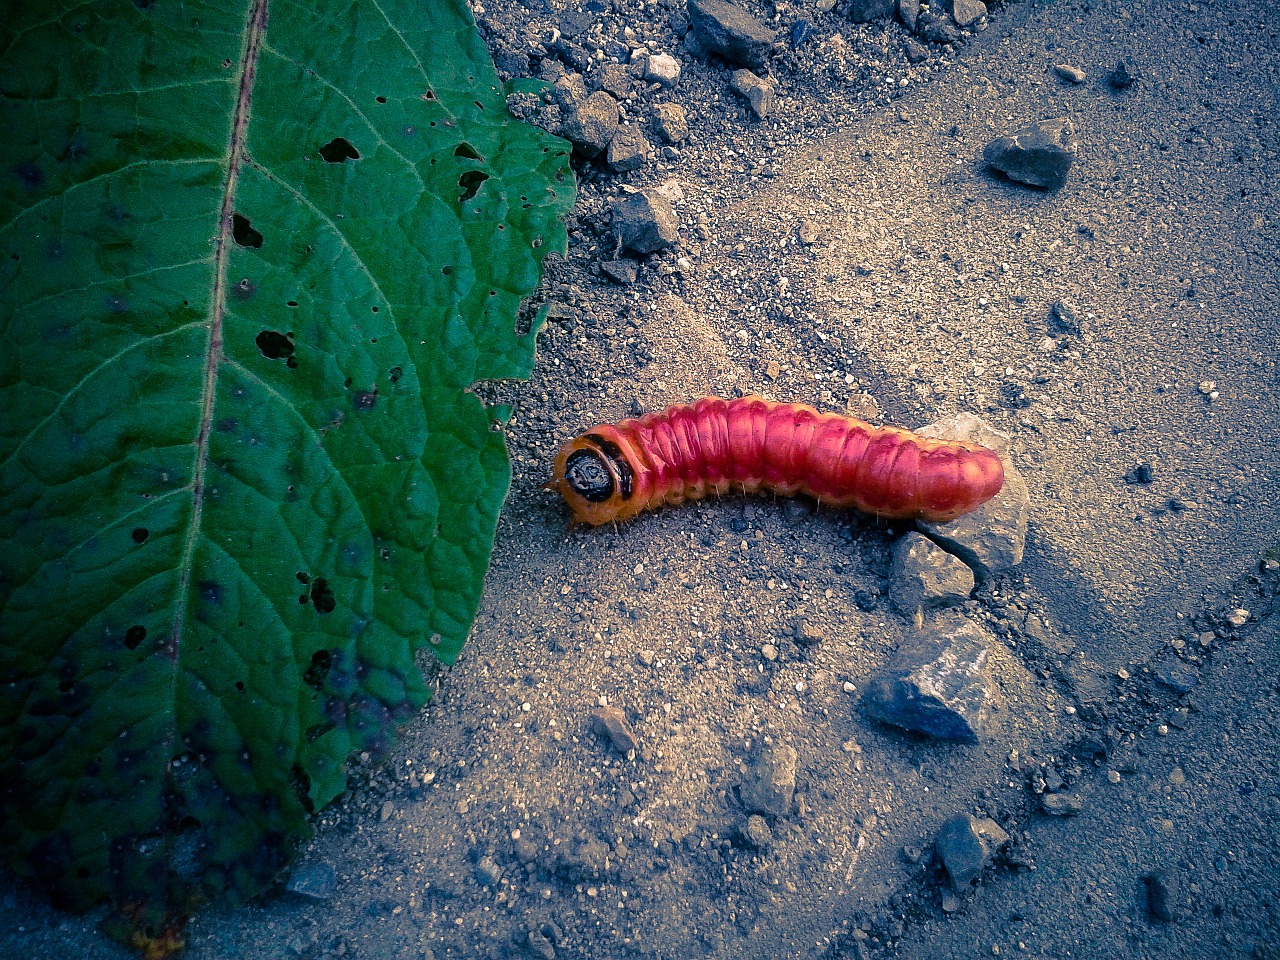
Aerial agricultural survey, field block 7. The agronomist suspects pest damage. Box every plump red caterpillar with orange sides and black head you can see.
[547,397,1005,535]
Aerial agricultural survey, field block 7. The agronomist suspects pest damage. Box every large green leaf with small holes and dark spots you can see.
[0,0,573,952]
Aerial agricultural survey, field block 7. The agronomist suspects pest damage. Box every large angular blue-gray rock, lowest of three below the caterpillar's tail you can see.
[863,618,992,744]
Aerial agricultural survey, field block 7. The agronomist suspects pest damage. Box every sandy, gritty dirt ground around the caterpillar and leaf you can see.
[0,0,1280,960]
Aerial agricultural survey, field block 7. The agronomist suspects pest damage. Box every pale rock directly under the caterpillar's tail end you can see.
[916,413,1030,581]
